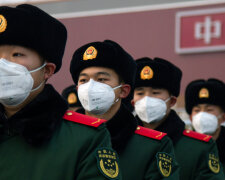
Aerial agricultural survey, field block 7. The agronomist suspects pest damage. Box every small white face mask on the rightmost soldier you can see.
[192,112,219,134]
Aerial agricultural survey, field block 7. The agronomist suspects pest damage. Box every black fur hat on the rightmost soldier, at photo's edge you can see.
[185,78,225,114]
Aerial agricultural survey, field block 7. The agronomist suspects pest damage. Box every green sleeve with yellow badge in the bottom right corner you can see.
[193,139,225,180]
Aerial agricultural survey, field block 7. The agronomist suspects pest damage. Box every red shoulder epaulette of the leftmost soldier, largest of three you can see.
[63,111,106,127]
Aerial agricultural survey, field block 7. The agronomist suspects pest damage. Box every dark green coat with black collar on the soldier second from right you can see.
[139,110,225,180]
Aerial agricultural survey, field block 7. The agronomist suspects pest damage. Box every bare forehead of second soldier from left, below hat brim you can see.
[80,66,118,78]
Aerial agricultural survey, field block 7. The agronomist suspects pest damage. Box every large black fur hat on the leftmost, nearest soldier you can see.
[0,4,67,72]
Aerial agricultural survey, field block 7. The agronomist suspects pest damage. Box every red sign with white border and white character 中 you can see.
[175,8,225,53]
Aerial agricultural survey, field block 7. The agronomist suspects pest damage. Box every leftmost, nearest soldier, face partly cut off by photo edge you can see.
[0,4,120,180]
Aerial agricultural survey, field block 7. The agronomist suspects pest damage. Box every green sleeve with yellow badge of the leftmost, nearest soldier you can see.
[75,125,122,180]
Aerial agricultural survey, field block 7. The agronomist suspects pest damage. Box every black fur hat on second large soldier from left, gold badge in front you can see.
[70,40,137,86]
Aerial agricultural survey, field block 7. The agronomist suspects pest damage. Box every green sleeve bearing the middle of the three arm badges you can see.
[145,136,179,180]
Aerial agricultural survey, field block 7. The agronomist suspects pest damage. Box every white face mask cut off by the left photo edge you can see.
[0,58,46,106]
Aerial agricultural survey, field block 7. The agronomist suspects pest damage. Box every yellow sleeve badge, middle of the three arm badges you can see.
[156,152,173,177]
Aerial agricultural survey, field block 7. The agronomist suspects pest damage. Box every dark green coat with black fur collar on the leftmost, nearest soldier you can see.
[0,86,119,180]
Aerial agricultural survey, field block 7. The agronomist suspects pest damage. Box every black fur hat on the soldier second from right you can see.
[135,57,182,97]
